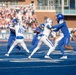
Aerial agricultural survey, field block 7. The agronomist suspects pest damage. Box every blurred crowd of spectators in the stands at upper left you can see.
[0,4,38,32]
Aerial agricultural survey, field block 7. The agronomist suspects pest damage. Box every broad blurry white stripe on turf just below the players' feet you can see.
[0,58,64,63]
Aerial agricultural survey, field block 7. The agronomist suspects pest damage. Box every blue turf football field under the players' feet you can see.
[0,42,76,75]
